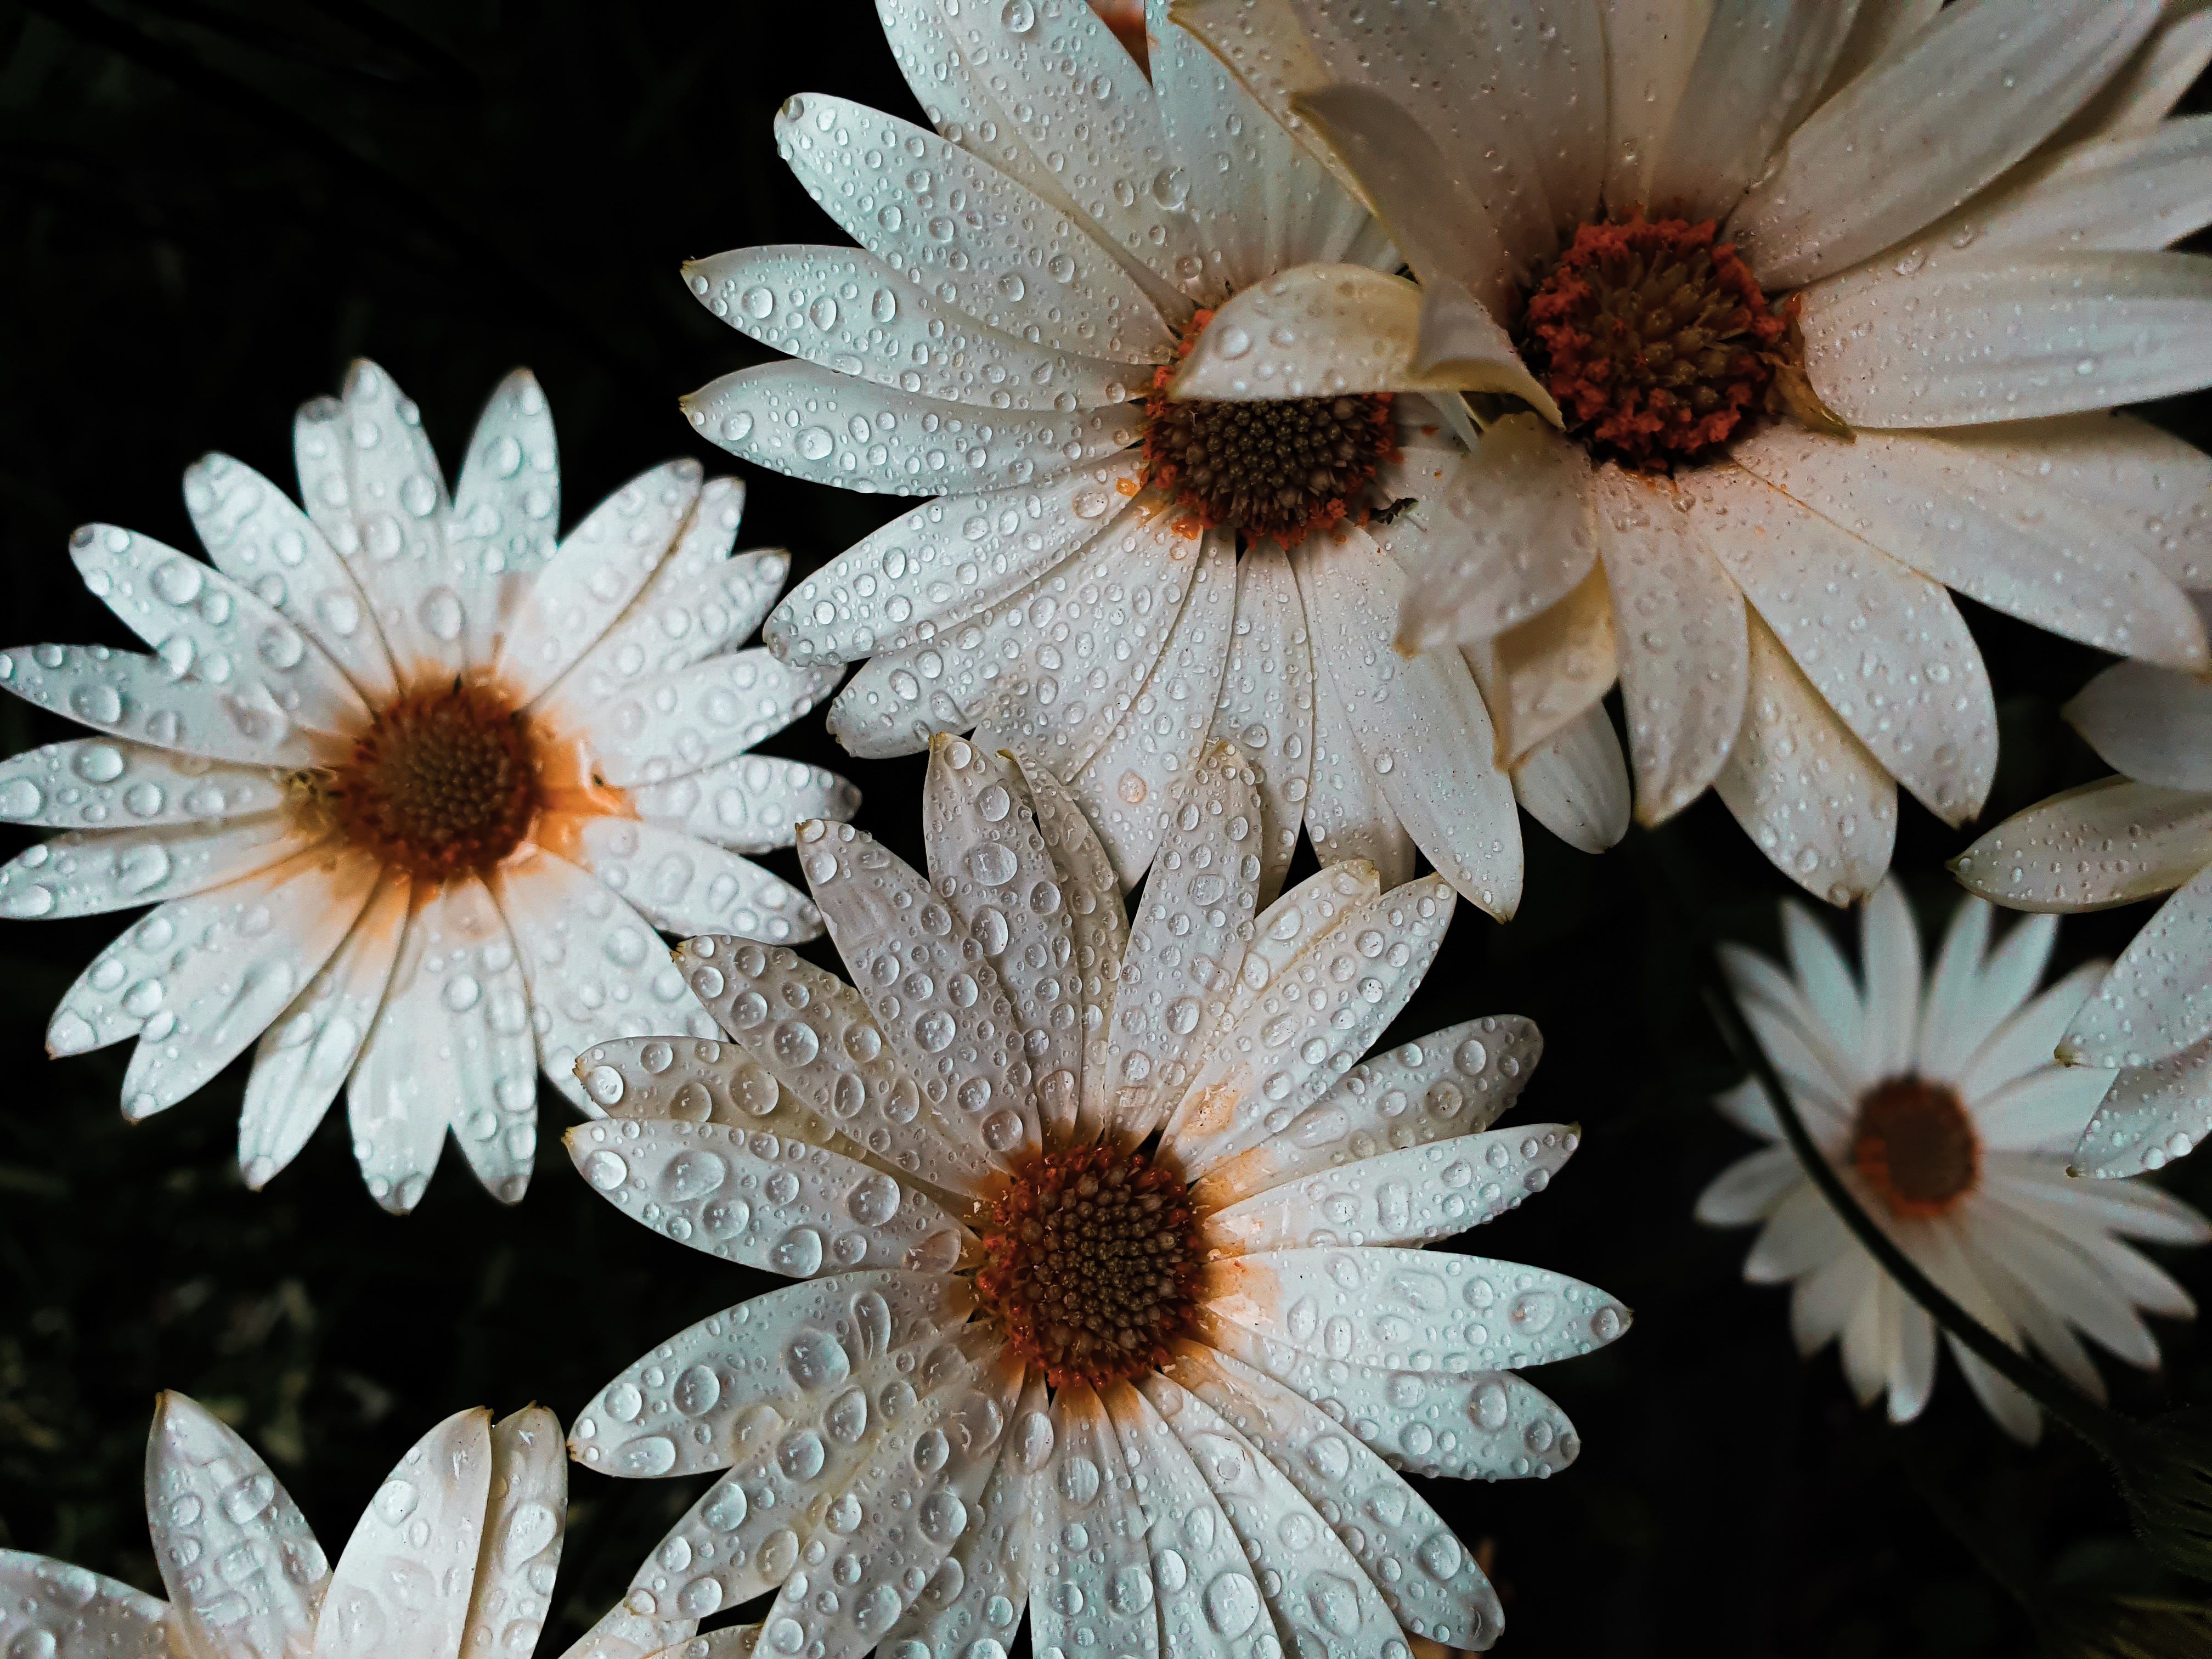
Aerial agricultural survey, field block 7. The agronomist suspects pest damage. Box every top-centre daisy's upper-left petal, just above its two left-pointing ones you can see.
[776,93,1175,363]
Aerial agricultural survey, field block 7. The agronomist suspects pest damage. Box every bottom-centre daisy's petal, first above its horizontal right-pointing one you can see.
[1205,1124,1582,1256]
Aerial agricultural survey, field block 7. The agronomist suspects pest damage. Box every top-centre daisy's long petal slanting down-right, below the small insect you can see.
[1296,531,1522,920]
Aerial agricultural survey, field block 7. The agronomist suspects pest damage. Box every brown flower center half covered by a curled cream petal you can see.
[1144,312,1398,546]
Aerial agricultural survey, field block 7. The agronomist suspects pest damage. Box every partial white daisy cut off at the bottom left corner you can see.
[0,1393,695,1659]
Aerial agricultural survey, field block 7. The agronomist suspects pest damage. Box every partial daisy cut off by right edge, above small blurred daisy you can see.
[1951,650,2212,1175]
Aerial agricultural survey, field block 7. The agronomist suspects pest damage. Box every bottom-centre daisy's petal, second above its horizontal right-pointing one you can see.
[1192,1008,1544,1215]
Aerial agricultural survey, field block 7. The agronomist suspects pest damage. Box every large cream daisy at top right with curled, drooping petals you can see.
[1172,0,2212,902]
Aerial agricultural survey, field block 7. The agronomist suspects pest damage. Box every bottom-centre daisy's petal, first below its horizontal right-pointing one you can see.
[1192,1307,1582,1480]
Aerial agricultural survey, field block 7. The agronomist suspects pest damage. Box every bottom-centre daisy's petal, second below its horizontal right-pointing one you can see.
[1168,1342,1504,1648]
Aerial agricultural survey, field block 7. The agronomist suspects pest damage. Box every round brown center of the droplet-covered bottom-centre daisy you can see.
[975,1146,1199,1389]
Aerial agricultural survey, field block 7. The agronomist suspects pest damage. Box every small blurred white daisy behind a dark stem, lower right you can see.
[1697,883,2212,1440]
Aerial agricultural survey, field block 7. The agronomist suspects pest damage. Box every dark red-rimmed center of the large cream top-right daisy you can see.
[1522,217,1796,471]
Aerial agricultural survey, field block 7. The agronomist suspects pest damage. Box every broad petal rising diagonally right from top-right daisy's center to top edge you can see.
[1728,0,2159,290]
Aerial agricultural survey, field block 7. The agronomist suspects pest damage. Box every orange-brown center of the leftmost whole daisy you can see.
[325,681,542,881]
